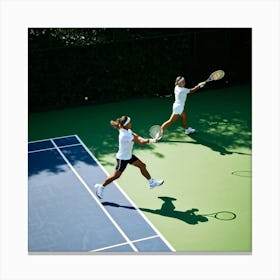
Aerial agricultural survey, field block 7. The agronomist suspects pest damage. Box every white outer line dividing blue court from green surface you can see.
[75,135,176,252]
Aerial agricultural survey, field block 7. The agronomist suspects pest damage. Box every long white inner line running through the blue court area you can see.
[50,139,138,252]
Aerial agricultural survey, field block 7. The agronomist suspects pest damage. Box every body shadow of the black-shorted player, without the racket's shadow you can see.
[102,196,208,225]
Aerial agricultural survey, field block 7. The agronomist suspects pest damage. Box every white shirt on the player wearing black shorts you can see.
[116,128,134,160]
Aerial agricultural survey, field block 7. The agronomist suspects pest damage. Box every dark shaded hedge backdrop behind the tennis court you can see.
[28,28,251,112]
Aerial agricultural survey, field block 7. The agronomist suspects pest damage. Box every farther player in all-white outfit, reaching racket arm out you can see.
[161,76,205,134]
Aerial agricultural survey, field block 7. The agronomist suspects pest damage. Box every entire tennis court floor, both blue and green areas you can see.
[29,85,252,253]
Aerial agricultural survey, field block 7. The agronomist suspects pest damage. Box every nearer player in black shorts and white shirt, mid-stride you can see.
[95,116,164,198]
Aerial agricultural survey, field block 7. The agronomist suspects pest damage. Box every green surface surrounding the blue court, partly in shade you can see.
[28,85,252,252]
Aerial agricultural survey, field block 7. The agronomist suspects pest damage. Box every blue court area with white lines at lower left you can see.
[28,135,175,253]
